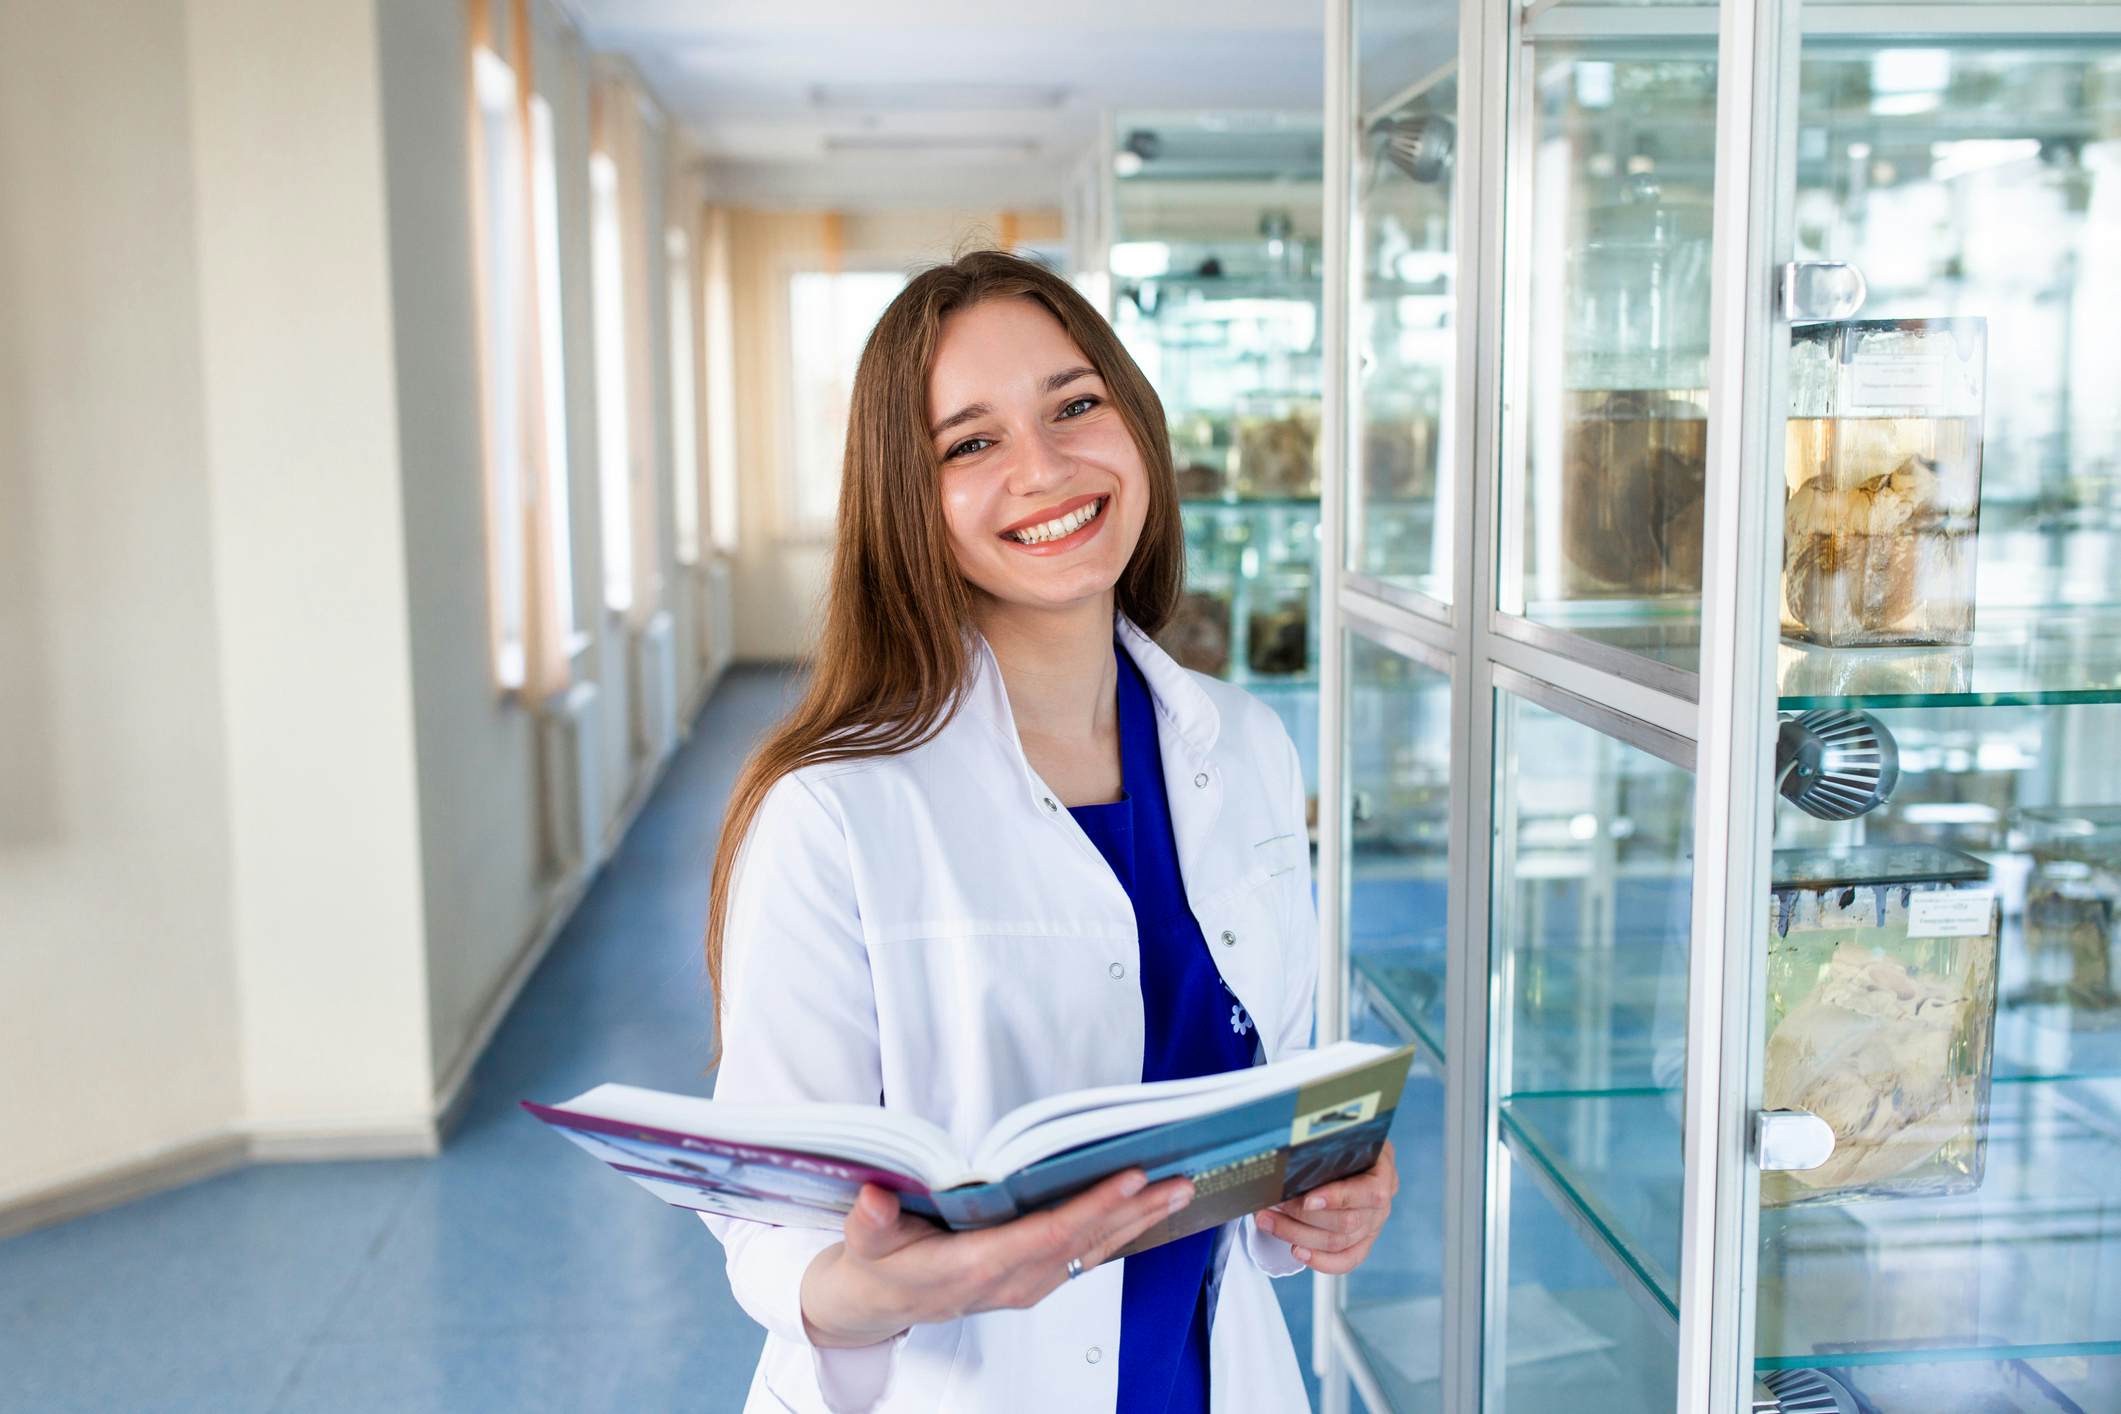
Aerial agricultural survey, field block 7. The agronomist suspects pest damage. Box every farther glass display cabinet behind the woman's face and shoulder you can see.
[1109,110,1324,793]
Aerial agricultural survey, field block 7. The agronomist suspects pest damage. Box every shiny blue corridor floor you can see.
[0,670,1311,1414]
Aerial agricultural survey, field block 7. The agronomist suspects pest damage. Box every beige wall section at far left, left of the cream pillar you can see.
[0,0,242,1204]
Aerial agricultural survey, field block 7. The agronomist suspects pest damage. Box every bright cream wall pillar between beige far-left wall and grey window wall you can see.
[182,0,445,1147]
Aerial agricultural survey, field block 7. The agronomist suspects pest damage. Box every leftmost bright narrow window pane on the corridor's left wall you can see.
[471,49,528,689]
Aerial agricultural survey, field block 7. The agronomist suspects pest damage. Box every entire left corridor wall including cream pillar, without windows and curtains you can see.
[0,0,716,1230]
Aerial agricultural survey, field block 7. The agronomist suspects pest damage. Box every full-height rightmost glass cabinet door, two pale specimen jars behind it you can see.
[1739,0,2121,1414]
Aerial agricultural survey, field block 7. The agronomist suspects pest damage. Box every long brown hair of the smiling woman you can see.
[706,250,1186,1058]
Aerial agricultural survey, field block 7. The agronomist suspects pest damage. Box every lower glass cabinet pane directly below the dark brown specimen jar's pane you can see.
[1485,674,1695,1414]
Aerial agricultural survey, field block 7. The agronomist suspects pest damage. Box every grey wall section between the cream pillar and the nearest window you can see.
[375,0,541,1085]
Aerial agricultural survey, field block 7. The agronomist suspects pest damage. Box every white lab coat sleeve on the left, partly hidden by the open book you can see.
[700,776,904,1410]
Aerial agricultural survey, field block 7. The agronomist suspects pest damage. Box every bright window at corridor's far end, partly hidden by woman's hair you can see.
[783,269,906,534]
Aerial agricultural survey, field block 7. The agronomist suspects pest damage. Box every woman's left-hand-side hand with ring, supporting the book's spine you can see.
[802,1168,1192,1346]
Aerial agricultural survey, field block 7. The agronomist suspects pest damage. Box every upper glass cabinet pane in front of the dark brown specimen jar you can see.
[1495,0,1718,693]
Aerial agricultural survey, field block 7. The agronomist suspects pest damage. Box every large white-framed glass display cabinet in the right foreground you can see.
[1313,0,2121,1414]
